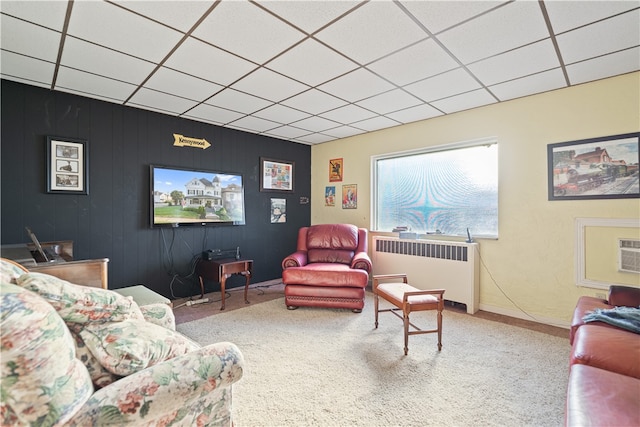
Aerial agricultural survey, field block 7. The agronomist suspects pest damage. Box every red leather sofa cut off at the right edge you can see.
[565,286,640,426]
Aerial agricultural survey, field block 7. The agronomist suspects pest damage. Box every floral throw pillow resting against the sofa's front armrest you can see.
[80,319,200,376]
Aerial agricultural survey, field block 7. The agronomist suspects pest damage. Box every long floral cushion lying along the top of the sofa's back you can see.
[17,273,143,323]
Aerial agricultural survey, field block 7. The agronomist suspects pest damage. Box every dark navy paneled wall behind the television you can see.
[0,80,311,297]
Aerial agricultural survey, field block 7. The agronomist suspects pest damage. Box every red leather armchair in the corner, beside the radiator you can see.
[282,224,371,313]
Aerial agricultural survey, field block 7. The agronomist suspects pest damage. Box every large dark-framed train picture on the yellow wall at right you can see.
[547,132,640,200]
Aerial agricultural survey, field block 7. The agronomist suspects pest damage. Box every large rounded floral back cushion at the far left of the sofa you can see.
[0,283,93,426]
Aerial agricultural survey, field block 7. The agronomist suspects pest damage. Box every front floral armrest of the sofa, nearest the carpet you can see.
[67,342,244,426]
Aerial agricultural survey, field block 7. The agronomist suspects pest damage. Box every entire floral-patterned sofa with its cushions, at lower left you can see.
[0,259,244,426]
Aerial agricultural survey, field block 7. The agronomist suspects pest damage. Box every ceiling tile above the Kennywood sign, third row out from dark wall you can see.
[164,38,255,86]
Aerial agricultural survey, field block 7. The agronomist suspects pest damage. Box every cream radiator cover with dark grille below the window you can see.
[372,236,480,314]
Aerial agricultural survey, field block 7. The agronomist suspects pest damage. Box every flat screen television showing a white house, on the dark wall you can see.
[150,165,245,228]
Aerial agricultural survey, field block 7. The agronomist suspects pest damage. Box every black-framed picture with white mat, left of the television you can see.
[46,136,89,194]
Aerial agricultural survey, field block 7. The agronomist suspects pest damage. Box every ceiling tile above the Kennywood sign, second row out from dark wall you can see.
[145,67,223,101]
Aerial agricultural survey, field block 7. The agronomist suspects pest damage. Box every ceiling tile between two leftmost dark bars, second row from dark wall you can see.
[61,37,154,84]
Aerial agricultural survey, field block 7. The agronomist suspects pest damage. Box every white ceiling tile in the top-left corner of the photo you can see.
[0,0,67,32]
